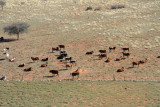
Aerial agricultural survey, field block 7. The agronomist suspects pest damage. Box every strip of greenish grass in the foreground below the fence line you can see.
[0,81,160,107]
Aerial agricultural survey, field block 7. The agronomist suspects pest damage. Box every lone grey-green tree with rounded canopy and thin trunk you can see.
[4,22,29,40]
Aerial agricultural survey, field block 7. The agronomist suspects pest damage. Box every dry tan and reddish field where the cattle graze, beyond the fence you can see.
[0,0,160,80]
